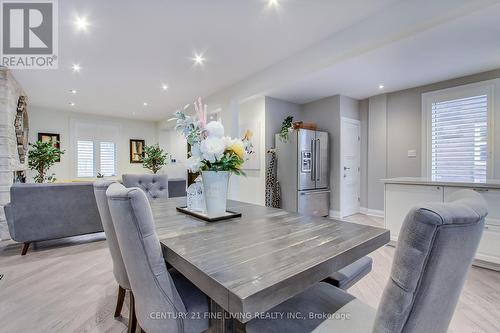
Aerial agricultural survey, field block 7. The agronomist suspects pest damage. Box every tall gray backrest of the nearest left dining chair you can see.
[106,184,186,333]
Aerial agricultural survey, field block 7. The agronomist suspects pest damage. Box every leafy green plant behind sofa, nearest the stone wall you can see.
[28,141,64,183]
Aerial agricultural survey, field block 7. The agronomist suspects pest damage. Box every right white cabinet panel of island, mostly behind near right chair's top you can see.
[444,187,500,265]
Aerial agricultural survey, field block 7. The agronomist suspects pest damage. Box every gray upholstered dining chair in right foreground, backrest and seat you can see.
[246,190,488,333]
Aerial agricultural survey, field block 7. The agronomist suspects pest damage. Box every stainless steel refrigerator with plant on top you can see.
[275,129,330,216]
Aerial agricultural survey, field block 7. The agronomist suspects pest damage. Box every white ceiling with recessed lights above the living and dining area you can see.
[10,0,396,120]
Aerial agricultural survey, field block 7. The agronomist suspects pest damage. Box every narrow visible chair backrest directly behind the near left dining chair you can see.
[94,180,130,290]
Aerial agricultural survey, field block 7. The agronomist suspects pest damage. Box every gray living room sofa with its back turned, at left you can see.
[4,182,103,255]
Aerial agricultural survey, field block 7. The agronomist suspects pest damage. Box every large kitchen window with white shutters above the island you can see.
[424,84,492,182]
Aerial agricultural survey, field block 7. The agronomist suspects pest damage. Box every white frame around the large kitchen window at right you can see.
[422,80,499,179]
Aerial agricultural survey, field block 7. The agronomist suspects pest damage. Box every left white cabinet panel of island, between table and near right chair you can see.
[385,184,444,241]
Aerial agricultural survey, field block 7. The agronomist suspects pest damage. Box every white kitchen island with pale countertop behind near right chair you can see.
[382,177,500,270]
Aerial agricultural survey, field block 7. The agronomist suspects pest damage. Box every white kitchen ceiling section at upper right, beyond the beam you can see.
[266,1,500,104]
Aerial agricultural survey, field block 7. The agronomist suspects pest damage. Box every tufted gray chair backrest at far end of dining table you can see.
[122,174,168,200]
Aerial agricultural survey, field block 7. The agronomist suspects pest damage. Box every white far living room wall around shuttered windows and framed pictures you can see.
[28,106,158,181]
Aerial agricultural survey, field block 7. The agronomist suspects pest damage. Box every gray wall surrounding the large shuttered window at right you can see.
[359,69,500,210]
